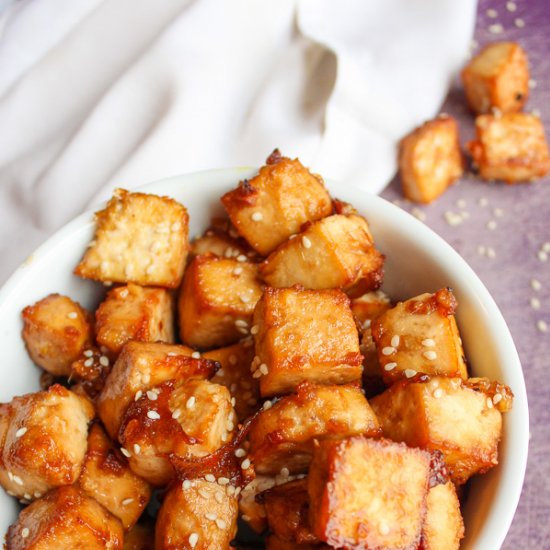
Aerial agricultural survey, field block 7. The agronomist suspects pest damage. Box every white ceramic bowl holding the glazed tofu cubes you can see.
[0,168,529,550]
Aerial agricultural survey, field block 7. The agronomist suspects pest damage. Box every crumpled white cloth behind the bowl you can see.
[0,0,476,282]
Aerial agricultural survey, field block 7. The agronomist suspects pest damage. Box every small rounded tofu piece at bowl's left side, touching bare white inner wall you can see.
[23,294,92,376]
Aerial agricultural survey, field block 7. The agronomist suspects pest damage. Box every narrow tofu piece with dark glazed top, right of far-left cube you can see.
[78,424,151,530]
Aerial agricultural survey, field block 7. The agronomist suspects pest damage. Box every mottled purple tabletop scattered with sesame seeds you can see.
[382,0,550,550]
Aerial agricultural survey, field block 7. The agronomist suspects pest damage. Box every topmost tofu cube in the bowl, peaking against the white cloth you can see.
[221,150,332,256]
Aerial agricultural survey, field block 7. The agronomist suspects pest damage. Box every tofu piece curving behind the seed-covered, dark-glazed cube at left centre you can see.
[97,341,217,441]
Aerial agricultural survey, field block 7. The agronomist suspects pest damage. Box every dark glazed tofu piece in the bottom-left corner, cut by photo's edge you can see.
[6,486,124,550]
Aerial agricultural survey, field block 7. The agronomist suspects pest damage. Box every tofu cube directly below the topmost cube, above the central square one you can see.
[260,215,384,296]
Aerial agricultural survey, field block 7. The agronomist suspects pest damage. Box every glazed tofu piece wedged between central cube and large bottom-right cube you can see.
[248,382,381,475]
